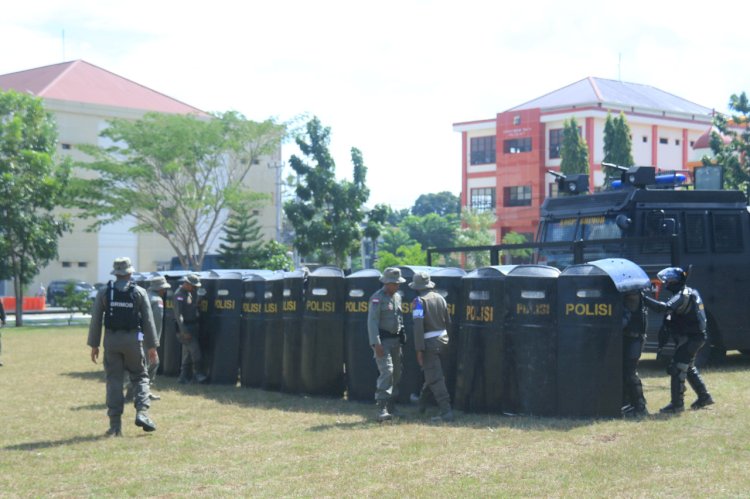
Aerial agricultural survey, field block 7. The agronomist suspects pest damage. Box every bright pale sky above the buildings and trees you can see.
[0,0,750,209]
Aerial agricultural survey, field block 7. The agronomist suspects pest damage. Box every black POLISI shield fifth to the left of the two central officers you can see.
[240,271,273,388]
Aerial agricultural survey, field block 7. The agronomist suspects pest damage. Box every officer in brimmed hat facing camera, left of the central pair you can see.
[367,268,406,421]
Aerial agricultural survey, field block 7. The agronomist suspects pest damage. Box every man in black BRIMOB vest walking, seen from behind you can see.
[87,257,159,437]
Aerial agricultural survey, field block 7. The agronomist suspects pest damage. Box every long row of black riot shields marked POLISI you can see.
[137,259,650,417]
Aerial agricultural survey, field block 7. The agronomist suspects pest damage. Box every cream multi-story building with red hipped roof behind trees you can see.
[0,60,281,291]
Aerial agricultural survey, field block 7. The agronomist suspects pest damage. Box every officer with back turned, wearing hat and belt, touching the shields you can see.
[409,272,453,422]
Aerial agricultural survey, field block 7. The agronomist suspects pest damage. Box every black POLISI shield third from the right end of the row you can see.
[454,265,514,412]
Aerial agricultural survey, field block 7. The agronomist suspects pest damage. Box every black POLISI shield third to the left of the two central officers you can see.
[281,270,307,393]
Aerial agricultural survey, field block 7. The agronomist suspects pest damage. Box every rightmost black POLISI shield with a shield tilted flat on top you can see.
[557,258,649,417]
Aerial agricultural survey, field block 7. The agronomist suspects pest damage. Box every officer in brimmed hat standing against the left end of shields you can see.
[174,274,208,384]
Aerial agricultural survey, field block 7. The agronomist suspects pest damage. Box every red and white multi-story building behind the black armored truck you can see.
[453,77,713,243]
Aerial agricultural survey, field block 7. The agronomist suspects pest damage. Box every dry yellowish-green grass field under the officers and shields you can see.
[0,326,750,497]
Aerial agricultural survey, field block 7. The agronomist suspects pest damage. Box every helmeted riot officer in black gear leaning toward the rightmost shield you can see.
[646,267,714,414]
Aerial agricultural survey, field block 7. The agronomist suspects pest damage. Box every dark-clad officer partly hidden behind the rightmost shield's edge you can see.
[622,291,648,417]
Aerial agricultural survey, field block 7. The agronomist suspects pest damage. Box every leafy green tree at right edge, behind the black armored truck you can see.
[703,92,750,191]
